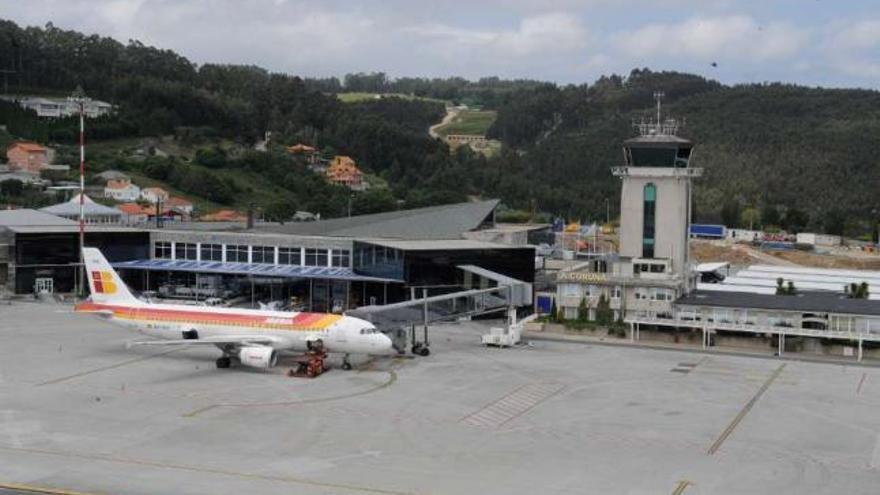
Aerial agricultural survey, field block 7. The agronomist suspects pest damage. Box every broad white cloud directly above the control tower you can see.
[614,15,809,62]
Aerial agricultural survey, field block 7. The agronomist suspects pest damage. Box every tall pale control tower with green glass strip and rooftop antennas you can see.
[611,93,702,291]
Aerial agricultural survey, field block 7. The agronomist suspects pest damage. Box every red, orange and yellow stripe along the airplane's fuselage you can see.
[75,302,342,331]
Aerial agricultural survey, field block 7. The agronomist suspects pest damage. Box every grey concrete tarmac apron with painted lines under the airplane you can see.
[0,303,880,495]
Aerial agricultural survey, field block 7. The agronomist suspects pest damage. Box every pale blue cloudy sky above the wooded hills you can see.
[0,0,880,89]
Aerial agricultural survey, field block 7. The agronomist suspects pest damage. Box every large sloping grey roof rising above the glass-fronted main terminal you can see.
[252,199,498,239]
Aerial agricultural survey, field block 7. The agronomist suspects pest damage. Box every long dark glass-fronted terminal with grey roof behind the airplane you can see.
[0,200,534,312]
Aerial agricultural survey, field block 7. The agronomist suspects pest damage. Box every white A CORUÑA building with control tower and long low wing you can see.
[556,104,880,359]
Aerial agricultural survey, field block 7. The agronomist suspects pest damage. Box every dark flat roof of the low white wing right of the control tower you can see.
[675,290,880,316]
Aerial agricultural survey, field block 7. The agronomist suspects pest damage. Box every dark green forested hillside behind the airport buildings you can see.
[0,21,880,236]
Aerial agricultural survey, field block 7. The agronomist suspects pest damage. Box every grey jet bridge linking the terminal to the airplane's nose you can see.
[346,265,532,356]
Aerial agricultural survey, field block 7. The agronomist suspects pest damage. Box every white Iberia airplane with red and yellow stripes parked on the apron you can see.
[74,248,396,370]
